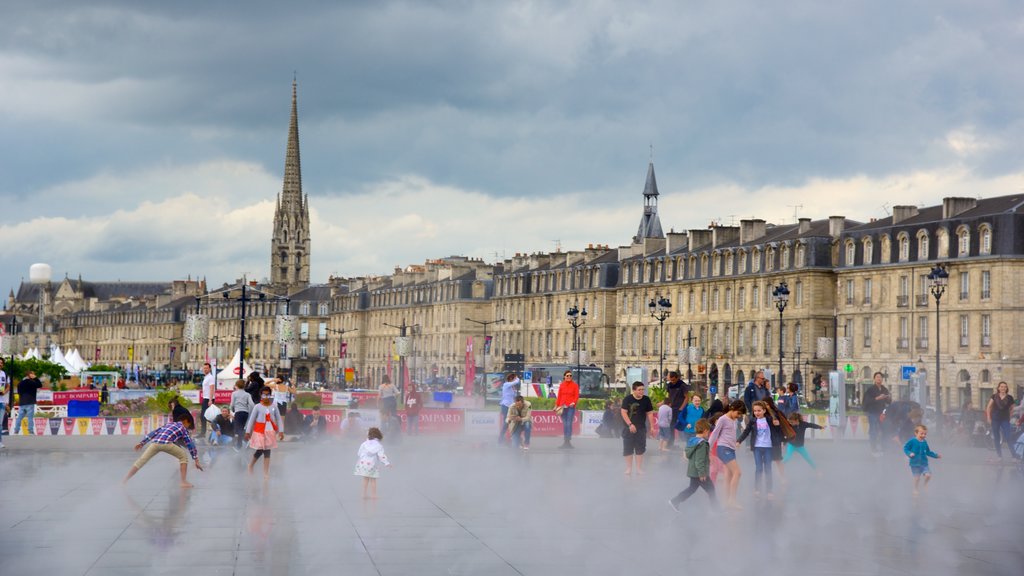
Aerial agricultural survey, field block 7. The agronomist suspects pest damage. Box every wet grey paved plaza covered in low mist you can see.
[0,437,1024,576]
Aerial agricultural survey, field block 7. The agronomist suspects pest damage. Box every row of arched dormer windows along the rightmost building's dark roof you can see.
[845,223,992,266]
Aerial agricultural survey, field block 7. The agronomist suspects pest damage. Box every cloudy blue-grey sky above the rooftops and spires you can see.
[0,0,1024,291]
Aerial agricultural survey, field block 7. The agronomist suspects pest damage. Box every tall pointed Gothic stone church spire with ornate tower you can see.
[270,79,310,293]
